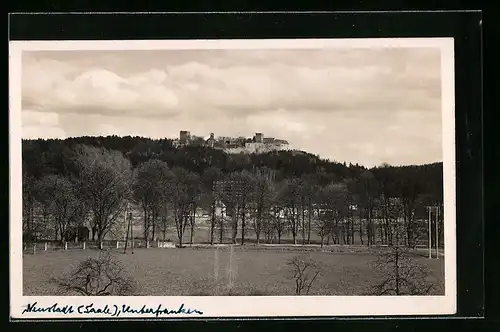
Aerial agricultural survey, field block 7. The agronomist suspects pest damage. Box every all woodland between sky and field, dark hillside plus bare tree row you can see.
[23,136,442,246]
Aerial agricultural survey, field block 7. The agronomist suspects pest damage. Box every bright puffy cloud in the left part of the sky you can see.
[23,62,178,116]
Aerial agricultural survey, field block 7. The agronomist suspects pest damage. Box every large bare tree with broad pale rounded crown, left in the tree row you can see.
[75,145,133,242]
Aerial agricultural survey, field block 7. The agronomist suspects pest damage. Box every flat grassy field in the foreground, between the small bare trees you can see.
[23,246,444,296]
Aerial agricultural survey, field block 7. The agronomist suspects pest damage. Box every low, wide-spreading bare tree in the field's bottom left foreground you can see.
[52,251,135,296]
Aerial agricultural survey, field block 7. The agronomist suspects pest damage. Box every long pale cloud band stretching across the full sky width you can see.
[23,48,440,116]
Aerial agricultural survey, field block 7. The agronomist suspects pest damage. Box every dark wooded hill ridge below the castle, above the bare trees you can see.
[22,136,443,192]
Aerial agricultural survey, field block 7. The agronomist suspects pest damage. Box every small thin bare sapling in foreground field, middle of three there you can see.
[287,255,324,295]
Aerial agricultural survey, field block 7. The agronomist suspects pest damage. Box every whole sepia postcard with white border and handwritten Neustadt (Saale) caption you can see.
[9,38,456,318]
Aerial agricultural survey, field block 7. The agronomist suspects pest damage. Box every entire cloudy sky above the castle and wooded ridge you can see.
[22,48,442,167]
